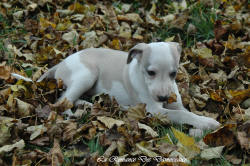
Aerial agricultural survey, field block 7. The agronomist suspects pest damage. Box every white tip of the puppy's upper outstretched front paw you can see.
[194,116,221,129]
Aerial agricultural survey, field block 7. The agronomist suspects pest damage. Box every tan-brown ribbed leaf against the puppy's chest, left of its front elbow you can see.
[127,104,146,120]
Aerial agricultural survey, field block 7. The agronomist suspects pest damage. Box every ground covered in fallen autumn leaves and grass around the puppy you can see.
[0,0,250,165]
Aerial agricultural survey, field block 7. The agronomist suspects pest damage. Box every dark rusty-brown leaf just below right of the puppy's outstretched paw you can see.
[203,124,236,146]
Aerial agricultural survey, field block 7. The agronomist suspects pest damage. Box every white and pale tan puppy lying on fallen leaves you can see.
[15,42,220,129]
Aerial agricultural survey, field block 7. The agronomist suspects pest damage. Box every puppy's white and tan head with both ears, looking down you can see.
[127,42,181,102]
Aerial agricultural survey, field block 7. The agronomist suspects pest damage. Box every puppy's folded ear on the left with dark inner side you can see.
[127,43,147,64]
